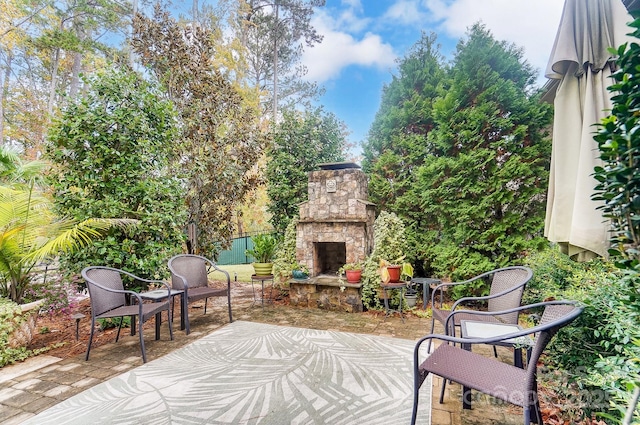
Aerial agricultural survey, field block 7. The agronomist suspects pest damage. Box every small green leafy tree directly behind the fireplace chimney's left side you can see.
[266,108,347,234]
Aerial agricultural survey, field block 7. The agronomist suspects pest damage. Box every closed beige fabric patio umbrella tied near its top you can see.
[544,0,633,259]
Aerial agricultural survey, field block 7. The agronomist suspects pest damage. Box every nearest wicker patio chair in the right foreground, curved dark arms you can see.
[411,301,583,425]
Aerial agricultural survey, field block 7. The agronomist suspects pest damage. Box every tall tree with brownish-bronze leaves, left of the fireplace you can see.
[132,7,267,255]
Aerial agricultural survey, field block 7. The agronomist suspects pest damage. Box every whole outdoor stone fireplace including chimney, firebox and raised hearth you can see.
[290,162,375,311]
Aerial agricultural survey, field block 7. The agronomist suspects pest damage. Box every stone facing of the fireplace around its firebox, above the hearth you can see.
[296,164,375,276]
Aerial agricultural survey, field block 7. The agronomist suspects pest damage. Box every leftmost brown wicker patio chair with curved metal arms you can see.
[82,266,173,363]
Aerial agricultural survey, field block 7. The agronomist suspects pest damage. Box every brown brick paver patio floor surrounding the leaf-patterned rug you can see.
[0,284,522,425]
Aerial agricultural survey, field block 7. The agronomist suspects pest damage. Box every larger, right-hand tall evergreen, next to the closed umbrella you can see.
[416,24,551,278]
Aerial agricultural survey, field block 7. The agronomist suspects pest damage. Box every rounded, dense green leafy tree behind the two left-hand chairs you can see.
[47,69,186,284]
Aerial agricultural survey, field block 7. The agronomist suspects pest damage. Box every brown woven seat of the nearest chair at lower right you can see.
[420,343,537,407]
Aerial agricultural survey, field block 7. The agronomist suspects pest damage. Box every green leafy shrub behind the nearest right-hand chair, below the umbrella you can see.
[523,247,640,423]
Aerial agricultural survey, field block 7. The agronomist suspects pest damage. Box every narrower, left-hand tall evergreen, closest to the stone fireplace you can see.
[363,33,446,216]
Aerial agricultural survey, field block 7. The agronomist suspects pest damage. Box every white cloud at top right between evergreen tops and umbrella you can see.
[423,0,564,81]
